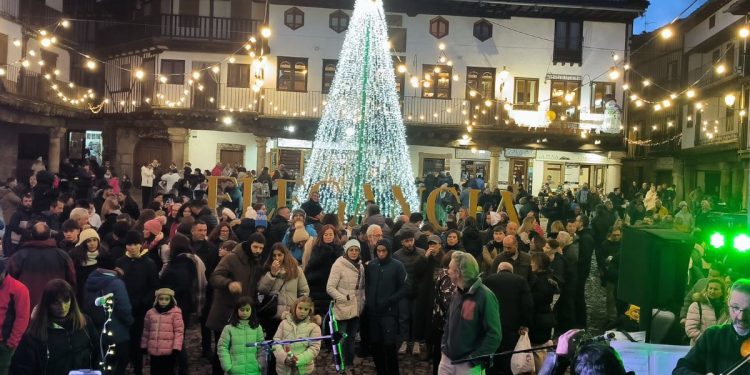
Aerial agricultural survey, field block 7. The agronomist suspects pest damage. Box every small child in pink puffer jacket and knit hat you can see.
[141,288,185,374]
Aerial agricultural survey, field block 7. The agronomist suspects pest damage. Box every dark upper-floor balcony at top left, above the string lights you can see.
[97,13,261,46]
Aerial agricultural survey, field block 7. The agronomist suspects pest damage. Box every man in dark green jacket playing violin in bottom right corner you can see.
[672,279,750,375]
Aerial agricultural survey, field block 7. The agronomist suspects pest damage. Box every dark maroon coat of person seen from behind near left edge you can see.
[7,239,76,309]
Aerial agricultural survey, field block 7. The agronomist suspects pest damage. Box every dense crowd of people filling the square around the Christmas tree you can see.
[0,157,748,375]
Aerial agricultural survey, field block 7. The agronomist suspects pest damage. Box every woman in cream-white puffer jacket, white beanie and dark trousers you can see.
[326,239,365,373]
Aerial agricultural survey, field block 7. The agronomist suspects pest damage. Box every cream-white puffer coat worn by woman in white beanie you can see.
[326,254,365,320]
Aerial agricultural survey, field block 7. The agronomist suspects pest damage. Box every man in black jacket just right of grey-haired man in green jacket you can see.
[484,262,534,375]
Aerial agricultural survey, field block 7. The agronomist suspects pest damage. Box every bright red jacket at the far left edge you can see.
[0,275,30,349]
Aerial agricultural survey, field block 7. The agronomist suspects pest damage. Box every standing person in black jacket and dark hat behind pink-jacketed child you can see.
[115,230,159,374]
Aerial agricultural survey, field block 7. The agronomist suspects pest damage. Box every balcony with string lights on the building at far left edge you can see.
[0,65,89,109]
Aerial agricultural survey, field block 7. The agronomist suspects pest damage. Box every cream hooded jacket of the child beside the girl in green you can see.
[273,311,320,375]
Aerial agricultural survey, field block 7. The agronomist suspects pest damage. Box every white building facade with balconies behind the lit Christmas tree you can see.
[0,0,647,200]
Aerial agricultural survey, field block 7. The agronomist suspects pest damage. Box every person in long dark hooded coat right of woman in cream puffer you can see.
[365,240,409,374]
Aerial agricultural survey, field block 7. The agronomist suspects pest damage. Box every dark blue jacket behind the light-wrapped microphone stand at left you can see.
[82,268,133,342]
